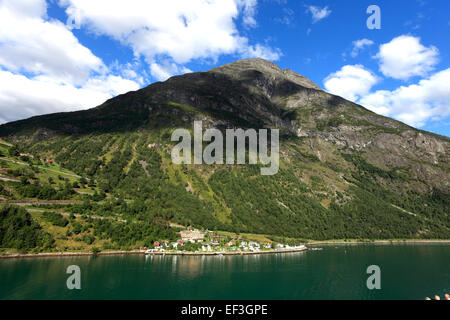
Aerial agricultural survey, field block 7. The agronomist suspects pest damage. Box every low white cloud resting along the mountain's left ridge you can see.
[0,70,139,123]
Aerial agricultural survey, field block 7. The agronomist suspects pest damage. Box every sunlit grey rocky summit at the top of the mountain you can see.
[208,58,321,90]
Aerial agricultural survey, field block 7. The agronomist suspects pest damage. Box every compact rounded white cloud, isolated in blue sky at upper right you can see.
[376,35,439,80]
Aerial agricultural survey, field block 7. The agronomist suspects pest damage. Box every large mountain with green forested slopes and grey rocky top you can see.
[0,59,450,239]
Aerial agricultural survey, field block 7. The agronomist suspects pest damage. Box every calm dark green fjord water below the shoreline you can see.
[0,244,450,299]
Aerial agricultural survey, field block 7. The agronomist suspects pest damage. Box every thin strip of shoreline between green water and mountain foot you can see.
[0,240,450,260]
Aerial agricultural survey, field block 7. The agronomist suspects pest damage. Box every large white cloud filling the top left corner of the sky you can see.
[0,0,106,84]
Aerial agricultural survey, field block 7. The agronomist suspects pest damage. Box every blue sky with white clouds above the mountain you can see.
[0,0,450,136]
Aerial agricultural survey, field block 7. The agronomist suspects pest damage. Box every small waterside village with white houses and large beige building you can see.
[141,229,307,254]
